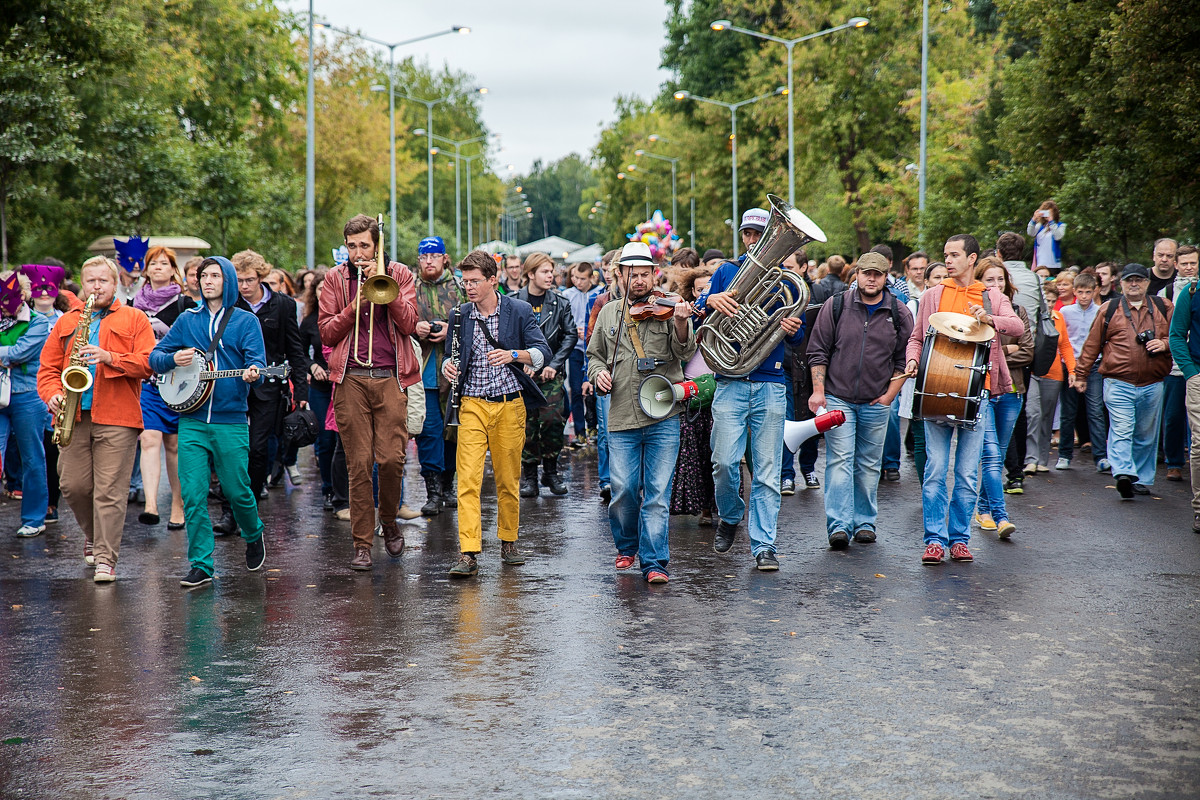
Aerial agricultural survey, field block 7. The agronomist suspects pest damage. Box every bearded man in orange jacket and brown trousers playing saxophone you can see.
[37,255,155,583]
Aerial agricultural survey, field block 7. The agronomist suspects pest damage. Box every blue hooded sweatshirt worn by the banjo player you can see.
[150,255,266,425]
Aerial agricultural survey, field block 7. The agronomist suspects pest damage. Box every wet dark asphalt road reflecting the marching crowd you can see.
[0,443,1200,799]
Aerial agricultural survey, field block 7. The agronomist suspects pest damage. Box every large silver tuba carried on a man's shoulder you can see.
[697,194,826,378]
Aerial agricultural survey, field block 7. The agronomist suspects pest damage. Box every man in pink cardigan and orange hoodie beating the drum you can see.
[905,234,1025,565]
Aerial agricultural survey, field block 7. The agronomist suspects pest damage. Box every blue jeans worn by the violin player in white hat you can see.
[608,415,679,575]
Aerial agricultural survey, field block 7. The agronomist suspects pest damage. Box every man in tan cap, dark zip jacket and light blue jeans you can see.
[809,253,913,551]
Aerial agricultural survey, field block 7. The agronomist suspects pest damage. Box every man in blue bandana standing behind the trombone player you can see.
[416,236,462,517]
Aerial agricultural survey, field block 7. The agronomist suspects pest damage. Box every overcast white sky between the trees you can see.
[280,0,667,174]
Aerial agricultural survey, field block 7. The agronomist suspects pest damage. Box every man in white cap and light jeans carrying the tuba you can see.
[696,209,804,572]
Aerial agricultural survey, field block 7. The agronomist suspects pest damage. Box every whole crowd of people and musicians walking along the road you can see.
[0,200,1200,588]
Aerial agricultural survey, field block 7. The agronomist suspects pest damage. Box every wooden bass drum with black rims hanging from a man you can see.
[912,327,991,431]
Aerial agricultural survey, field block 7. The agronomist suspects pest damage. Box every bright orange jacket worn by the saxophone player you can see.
[37,297,155,429]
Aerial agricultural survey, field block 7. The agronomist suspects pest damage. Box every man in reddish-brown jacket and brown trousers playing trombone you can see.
[317,213,421,570]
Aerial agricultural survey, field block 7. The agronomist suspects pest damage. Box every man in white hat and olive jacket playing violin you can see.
[588,242,696,583]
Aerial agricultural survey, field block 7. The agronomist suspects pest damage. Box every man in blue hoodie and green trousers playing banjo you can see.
[150,257,266,588]
